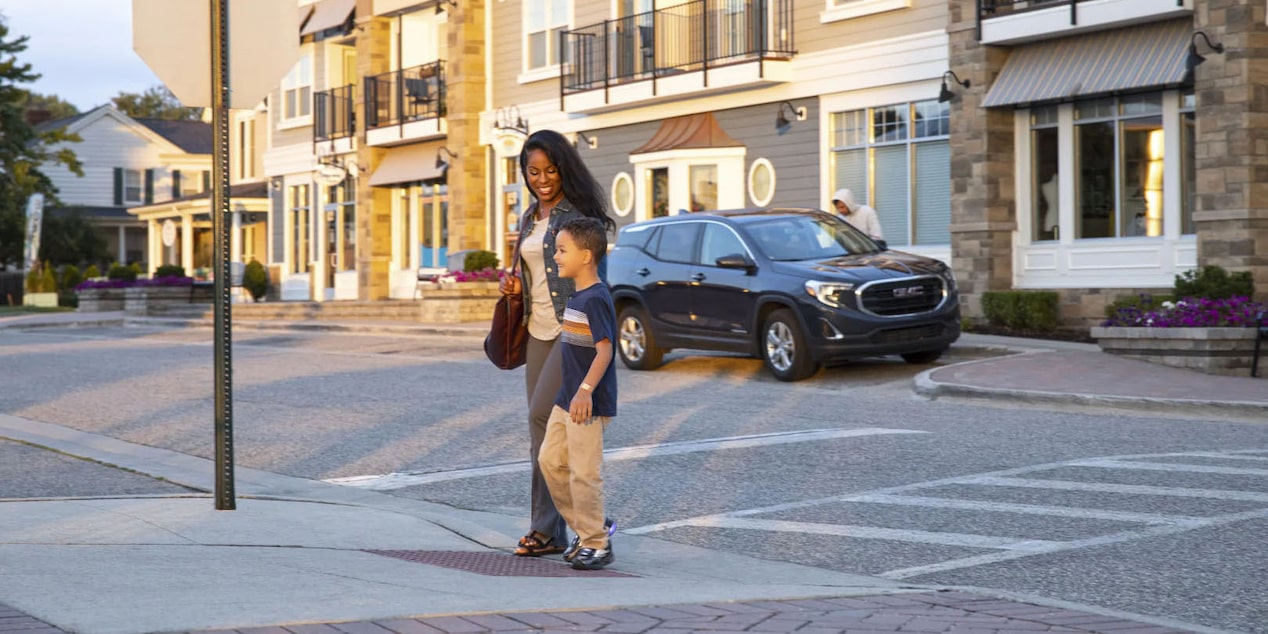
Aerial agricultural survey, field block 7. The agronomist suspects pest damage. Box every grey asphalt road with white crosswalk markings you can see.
[0,328,1268,633]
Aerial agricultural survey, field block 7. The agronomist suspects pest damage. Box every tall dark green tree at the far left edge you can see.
[0,16,84,266]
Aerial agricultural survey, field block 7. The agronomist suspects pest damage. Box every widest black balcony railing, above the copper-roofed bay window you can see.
[559,0,796,95]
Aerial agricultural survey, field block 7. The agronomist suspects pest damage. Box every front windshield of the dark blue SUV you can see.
[744,216,876,261]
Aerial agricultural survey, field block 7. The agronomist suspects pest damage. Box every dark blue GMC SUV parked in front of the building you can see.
[607,209,960,380]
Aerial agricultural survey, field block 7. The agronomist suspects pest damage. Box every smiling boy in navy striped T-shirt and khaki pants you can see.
[538,218,616,571]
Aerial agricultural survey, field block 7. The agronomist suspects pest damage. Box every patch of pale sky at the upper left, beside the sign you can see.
[0,0,161,112]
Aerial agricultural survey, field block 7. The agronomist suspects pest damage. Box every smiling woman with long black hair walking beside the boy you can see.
[501,129,616,557]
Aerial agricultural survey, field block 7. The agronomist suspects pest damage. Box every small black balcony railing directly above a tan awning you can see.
[365,60,445,128]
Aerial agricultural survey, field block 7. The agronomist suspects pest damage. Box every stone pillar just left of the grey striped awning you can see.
[947,0,1017,321]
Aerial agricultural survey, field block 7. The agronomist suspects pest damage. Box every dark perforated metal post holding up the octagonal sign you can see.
[210,0,236,511]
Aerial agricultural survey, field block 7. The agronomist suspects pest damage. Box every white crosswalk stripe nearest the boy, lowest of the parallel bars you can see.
[674,517,1060,552]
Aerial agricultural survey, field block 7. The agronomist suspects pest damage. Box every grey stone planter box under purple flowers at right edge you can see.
[1092,326,1258,377]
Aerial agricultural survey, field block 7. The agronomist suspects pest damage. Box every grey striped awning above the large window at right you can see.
[981,20,1192,108]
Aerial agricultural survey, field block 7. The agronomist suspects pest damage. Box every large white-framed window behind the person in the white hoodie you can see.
[829,100,951,245]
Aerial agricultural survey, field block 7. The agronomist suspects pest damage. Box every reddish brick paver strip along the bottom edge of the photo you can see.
[0,592,1188,634]
